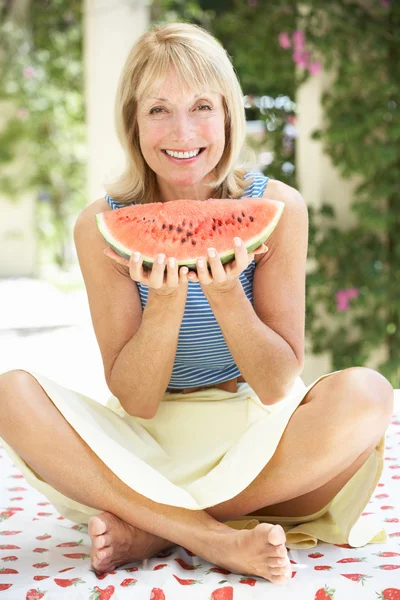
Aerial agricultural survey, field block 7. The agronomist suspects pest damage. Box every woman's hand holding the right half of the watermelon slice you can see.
[187,238,268,293]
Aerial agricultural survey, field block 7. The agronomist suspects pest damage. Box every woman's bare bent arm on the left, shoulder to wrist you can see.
[74,199,187,419]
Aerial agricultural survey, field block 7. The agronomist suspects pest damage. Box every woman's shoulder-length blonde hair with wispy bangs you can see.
[104,23,251,204]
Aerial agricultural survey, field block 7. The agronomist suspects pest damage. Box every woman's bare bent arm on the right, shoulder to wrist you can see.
[204,181,308,404]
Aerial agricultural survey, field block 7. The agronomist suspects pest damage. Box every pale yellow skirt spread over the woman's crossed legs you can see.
[0,371,386,548]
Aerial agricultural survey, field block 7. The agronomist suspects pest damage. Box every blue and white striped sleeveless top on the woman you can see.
[105,172,269,389]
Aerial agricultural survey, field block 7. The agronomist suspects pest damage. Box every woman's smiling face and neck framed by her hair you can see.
[137,69,225,201]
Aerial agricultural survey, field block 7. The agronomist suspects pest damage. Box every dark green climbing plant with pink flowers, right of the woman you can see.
[154,0,400,387]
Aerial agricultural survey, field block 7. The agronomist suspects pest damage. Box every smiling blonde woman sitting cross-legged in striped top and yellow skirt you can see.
[0,23,393,583]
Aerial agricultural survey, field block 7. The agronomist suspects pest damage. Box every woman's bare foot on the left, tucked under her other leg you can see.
[88,512,175,573]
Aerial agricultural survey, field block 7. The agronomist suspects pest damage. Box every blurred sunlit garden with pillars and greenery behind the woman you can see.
[0,0,400,400]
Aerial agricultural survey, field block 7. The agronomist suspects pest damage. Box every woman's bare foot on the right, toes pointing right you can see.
[205,523,292,583]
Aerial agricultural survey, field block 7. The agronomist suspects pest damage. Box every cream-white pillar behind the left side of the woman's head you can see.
[84,0,150,204]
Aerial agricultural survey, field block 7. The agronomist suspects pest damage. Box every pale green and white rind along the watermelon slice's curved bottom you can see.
[95,200,285,271]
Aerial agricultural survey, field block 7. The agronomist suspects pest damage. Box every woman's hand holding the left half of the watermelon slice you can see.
[104,248,188,296]
